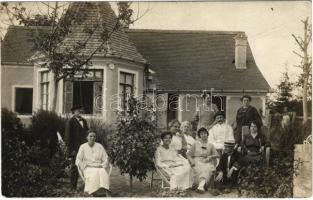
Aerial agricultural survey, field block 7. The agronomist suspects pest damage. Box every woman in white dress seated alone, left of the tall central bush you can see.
[75,131,110,196]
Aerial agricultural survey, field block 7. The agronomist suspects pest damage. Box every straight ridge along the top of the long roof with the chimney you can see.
[127,28,245,34]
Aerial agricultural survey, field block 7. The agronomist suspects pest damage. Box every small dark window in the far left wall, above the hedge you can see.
[14,88,33,115]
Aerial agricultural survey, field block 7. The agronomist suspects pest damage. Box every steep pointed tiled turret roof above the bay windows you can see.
[64,2,146,63]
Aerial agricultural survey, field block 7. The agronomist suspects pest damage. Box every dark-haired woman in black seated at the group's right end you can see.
[242,122,270,163]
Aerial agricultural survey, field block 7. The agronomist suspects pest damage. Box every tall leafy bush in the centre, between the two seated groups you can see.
[109,98,158,182]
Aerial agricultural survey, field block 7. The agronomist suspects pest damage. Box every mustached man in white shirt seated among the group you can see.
[209,111,234,155]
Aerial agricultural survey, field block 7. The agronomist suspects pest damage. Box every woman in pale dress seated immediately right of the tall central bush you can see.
[155,132,192,190]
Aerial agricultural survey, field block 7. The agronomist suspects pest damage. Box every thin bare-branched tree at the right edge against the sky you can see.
[292,17,312,124]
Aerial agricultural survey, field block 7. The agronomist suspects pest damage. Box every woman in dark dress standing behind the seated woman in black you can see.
[234,95,262,144]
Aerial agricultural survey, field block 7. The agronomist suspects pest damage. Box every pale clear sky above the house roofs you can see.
[0,1,312,88]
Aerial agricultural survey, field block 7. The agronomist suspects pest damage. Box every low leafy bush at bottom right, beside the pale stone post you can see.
[239,151,293,198]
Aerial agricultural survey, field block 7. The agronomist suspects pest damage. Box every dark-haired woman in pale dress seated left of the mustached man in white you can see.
[187,127,219,192]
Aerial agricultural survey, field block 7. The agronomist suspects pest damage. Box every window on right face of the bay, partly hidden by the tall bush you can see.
[119,72,135,110]
